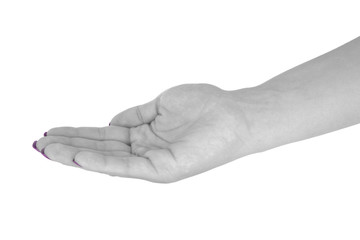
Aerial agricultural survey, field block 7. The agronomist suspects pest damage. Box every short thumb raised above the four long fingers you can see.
[110,98,158,127]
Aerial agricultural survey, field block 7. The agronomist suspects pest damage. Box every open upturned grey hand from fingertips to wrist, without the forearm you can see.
[34,84,251,182]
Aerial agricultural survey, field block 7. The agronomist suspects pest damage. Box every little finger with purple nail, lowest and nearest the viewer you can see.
[75,151,159,182]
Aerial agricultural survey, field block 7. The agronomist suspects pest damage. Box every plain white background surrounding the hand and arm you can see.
[0,0,360,240]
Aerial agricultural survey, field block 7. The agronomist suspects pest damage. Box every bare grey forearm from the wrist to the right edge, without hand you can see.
[233,38,360,153]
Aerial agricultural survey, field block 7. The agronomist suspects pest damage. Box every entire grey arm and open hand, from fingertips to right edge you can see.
[35,37,360,183]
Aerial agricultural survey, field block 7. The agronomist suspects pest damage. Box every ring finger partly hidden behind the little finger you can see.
[41,143,131,166]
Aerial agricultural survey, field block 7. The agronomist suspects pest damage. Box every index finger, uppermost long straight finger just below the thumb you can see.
[46,126,130,144]
